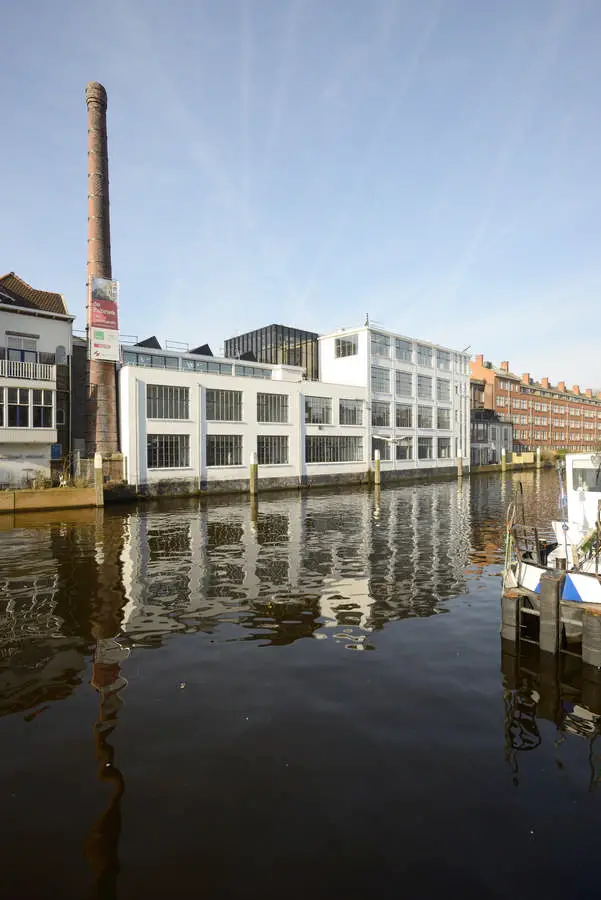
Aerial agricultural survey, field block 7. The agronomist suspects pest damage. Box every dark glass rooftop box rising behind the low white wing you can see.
[224,325,319,381]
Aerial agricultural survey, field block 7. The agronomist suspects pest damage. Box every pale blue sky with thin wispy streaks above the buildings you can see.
[0,0,601,389]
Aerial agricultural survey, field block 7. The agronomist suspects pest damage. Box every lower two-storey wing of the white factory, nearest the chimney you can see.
[119,345,369,490]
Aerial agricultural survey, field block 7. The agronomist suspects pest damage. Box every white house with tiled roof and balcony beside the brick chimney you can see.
[0,272,73,487]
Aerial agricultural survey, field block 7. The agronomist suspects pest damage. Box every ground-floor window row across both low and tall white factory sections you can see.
[146,434,451,469]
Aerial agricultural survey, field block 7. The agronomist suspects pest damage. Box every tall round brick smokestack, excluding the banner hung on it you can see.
[86,81,119,454]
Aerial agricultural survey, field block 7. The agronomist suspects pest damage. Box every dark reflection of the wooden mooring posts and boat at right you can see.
[501,641,601,790]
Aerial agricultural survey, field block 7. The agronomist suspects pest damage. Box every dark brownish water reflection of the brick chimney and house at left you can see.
[0,509,129,898]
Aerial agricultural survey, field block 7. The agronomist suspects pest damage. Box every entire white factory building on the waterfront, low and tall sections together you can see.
[119,327,469,492]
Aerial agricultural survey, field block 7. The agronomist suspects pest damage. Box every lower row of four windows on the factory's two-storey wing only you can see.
[146,434,363,469]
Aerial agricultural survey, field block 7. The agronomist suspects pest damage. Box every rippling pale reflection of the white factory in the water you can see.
[122,482,470,646]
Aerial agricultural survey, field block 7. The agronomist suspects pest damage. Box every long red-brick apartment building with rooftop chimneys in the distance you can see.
[470,354,601,453]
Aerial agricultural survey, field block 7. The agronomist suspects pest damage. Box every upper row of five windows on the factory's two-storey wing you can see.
[146,384,363,425]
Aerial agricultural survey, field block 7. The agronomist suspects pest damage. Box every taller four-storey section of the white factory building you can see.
[319,325,470,474]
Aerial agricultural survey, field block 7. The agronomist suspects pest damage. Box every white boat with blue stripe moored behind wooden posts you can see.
[503,453,601,603]
